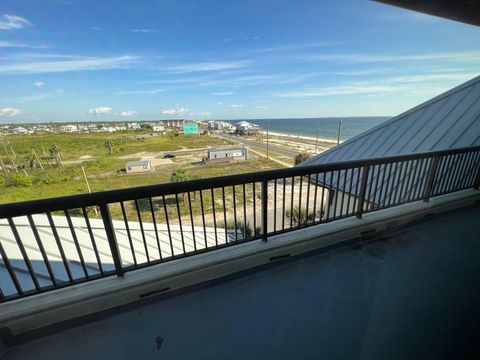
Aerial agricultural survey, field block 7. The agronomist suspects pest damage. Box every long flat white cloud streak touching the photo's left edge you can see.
[0,54,139,74]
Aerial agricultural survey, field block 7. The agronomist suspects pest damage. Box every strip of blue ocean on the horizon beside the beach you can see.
[230,116,390,141]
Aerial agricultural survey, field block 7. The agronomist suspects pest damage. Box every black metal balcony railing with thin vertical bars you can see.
[0,147,480,301]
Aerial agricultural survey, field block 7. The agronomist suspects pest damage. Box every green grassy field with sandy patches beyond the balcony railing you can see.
[0,132,281,217]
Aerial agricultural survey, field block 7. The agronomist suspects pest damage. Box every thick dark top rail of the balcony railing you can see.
[0,146,480,219]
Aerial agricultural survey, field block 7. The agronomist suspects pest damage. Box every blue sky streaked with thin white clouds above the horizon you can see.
[0,0,480,123]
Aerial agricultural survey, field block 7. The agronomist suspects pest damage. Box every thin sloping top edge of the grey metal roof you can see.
[304,75,480,165]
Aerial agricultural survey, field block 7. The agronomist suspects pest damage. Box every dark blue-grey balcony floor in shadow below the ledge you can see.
[5,206,480,360]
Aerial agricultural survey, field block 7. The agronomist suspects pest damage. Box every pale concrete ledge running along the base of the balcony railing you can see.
[0,189,480,335]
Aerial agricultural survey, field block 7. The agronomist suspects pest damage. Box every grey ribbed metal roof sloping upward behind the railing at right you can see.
[301,76,480,203]
